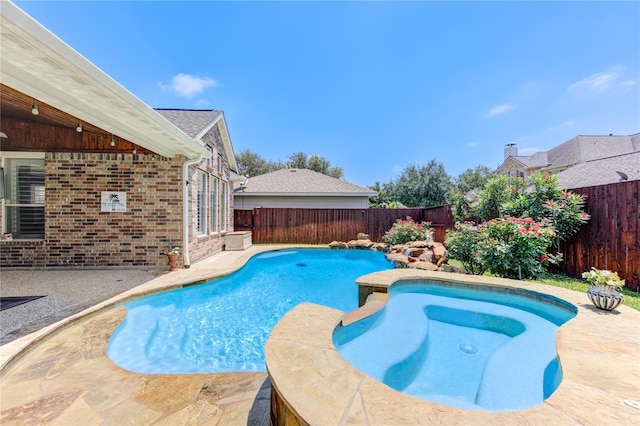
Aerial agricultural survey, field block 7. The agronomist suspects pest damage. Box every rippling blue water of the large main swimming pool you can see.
[107,249,393,374]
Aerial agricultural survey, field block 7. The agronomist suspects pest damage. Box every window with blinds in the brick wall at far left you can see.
[4,158,45,239]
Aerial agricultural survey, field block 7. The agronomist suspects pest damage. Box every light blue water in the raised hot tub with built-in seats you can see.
[334,284,577,411]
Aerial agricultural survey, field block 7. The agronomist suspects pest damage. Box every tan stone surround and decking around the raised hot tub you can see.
[266,269,640,425]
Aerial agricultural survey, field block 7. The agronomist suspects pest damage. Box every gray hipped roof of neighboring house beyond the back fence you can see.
[234,169,377,196]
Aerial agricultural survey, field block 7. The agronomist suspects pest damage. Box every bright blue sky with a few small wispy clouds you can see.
[15,1,640,186]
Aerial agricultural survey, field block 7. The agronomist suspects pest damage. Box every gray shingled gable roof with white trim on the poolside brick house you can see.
[156,108,238,172]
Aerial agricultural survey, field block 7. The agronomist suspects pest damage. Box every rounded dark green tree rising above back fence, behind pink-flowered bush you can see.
[391,159,453,207]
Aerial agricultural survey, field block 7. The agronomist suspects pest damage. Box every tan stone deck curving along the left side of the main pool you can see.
[0,245,300,426]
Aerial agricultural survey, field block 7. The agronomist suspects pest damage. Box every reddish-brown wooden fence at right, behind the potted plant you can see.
[559,180,640,291]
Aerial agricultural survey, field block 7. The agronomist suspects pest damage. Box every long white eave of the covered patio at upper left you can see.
[0,0,211,158]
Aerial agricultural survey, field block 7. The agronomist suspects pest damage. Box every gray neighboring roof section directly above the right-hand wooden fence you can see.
[558,152,640,189]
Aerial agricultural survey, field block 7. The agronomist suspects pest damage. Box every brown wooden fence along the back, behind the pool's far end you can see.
[234,205,453,244]
